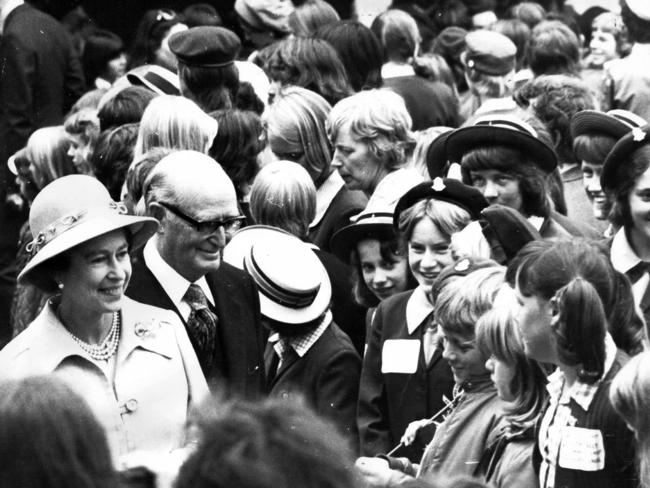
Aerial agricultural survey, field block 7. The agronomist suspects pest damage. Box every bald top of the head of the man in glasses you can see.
[145,151,237,207]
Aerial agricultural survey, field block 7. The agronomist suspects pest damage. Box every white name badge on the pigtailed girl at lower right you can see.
[558,427,605,471]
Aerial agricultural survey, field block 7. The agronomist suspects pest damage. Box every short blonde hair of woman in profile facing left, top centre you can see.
[327,89,415,171]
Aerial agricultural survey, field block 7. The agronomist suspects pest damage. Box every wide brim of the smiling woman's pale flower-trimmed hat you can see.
[18,212,158,285]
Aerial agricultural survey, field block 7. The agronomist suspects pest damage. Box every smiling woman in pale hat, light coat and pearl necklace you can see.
[0,175,207,467]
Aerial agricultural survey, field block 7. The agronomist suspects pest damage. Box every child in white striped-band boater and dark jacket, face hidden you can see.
[224,225,361,445]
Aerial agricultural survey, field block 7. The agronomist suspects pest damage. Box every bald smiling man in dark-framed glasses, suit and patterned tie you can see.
[127,151,264,397]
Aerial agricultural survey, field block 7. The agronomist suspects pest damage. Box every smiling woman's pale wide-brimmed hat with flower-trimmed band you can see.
[18,175,158,286]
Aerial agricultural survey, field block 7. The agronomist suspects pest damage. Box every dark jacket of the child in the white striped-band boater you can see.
[269,322,361,446]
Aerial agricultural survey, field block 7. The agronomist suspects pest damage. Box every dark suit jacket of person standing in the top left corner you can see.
[0,4,85,194]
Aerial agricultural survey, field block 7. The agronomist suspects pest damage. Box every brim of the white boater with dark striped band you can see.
[223,225,332,325]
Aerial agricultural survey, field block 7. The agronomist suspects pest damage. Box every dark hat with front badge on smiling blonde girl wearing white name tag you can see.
[393,178,488,228]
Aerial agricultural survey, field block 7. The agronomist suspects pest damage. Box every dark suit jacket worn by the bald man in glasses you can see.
[126,251,266,398]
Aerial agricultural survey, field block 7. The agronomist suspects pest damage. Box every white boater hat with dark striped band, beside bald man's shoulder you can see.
[223,225,332,324]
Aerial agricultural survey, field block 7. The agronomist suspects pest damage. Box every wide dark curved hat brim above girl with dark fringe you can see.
[444,125,557,174]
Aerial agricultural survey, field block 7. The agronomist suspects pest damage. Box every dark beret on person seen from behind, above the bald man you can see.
[169,26,241,68]
